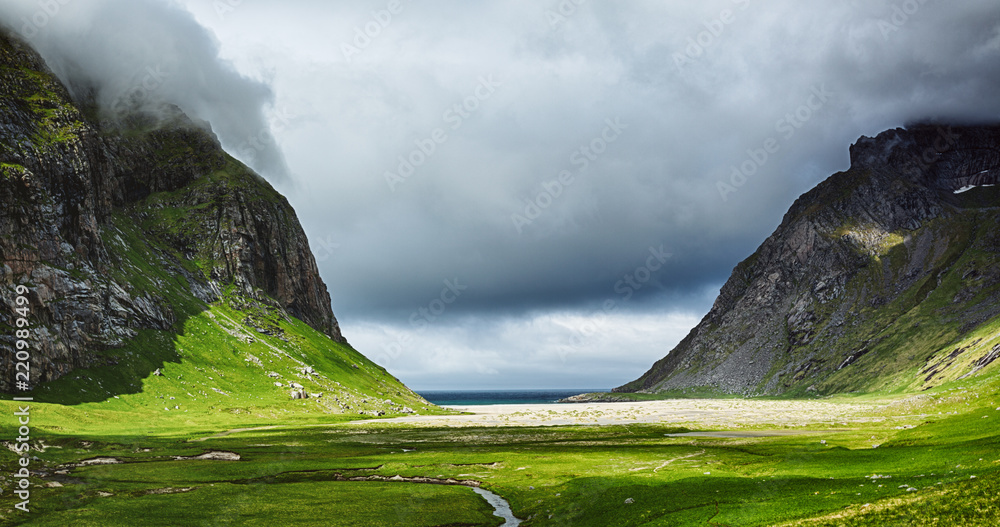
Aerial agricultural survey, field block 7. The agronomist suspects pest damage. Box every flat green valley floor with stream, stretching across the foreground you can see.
[0,383,1000,527]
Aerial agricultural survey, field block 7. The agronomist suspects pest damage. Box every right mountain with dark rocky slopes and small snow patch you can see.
[614,124,1000,395]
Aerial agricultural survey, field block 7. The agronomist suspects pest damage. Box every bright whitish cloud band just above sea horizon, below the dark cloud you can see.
[351,312,698,390]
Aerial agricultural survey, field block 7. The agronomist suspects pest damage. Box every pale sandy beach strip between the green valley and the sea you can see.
[359,399,883,428]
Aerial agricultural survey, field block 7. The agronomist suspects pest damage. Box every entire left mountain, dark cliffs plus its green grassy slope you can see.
[0,31,426,413]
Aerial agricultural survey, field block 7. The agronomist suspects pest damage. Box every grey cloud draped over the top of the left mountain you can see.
[0,0,287,180]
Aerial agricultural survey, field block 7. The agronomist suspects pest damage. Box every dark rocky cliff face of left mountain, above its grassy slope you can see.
[0,28,343,392]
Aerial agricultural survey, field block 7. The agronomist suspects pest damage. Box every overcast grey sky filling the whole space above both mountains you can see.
[0,0,1000,389]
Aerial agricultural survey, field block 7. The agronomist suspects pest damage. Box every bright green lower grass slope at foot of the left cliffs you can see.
[20,296,439,434]
